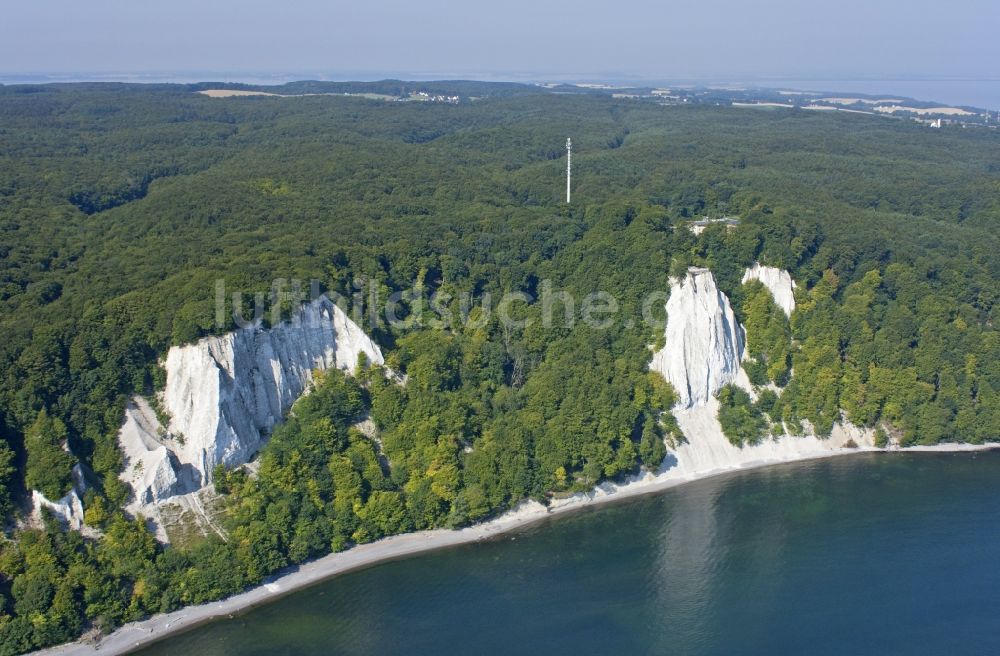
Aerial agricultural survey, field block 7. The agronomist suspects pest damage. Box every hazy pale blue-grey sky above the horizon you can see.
[0,0,1000,80]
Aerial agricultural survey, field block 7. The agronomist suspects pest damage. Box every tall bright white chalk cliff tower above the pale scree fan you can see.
[650,268,749,408]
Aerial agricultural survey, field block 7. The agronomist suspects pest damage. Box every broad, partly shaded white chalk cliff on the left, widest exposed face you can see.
[119,297,383,508]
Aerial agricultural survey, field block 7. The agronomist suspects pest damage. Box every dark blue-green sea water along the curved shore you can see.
[142,452,1000,656]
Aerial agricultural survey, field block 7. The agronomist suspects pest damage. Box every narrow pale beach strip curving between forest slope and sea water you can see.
[32,437,1000,656]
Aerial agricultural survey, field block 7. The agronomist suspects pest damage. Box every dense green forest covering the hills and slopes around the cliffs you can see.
[0,83,1000,653]
